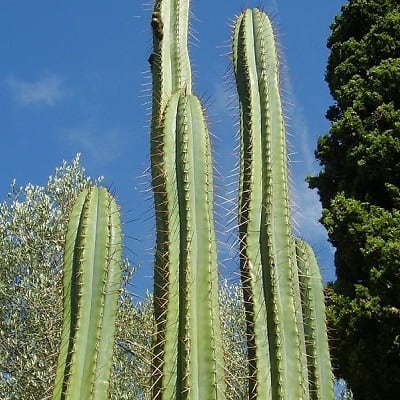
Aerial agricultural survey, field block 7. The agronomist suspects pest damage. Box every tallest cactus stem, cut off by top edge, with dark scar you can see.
[149,0,191,398]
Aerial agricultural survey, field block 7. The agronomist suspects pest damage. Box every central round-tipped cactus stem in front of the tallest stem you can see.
[153,90,225,400]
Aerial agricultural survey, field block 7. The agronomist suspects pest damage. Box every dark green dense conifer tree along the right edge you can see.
[309,0,400,399]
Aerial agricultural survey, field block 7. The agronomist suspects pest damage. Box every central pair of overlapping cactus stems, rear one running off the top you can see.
[149,0,225,399]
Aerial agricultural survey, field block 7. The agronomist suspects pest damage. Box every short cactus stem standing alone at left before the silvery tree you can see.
[53,186,122,400]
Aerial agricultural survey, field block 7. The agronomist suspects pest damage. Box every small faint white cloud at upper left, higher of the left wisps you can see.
[6,75,67,106]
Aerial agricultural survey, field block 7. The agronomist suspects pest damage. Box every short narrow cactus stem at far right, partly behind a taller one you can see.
[296,239,334,400]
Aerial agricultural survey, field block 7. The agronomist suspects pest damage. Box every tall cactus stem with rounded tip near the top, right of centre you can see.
[233,9,333,400]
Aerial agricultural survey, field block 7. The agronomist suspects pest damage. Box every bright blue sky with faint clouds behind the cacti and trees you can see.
[0,0,344,294]
